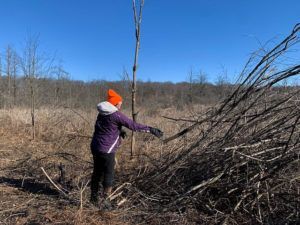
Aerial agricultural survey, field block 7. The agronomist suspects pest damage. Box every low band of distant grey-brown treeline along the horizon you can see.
[0,75,232,109]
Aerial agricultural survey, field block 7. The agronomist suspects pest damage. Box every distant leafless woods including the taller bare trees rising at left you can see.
[0,40,232,110]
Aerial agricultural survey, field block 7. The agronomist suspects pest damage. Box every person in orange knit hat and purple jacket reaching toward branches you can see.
[90,89,163,205]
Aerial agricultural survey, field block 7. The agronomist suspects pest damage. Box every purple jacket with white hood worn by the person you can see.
[91,102,150,154]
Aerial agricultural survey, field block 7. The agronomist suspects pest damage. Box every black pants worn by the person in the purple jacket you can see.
[91,153,115,196]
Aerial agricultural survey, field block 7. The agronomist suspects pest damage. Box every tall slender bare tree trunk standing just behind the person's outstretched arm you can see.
[131,0,144,156]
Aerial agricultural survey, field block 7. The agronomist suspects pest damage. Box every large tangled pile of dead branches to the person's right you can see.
[119,24,300,224]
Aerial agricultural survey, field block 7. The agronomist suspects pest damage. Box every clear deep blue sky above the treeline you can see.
[0,0,300,82]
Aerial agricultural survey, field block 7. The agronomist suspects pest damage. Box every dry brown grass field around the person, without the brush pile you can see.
[0,106,202,224]
